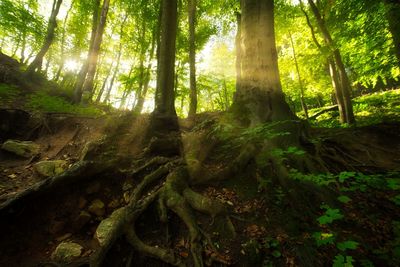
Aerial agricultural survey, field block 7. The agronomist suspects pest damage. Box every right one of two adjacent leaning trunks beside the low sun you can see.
[83,0,110,102]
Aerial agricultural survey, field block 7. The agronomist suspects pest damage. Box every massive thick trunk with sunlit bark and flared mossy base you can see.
[233,0,295,125]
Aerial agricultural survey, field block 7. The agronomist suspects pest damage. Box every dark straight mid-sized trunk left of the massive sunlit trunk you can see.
[154,0,178,117]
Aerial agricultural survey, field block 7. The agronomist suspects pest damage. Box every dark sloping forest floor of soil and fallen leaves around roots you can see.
[0,57,400,266]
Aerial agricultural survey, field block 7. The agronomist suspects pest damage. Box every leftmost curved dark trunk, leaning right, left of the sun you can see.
[26,0,62,75]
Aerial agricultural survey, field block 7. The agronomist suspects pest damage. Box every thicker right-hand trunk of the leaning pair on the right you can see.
[308,0,355,124]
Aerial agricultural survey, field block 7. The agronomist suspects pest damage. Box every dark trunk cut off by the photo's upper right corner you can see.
[384,0,400,65]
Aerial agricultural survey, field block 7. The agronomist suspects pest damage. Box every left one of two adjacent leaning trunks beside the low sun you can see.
[74,0,100,103]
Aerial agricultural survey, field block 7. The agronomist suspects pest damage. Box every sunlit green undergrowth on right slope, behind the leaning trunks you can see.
[299,89,400,127]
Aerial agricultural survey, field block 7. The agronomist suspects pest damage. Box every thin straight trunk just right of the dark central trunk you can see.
[188,0,197,117]
